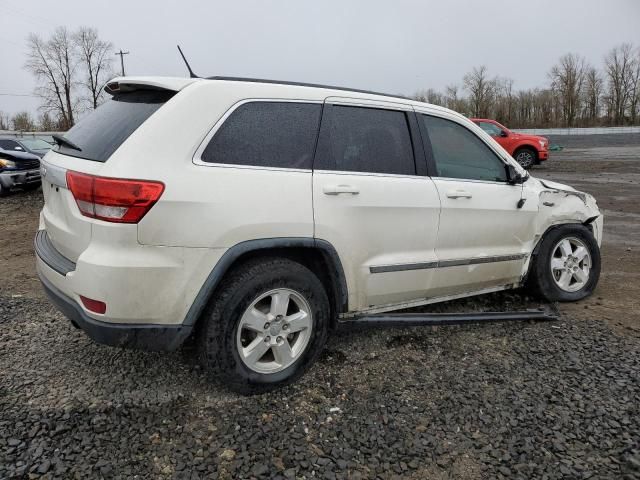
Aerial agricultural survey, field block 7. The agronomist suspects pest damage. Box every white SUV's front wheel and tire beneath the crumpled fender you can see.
[528,224,600,302]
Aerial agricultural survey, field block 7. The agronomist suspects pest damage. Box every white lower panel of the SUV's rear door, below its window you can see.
[313,172,440,310]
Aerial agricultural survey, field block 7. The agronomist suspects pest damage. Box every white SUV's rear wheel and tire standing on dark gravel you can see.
[198,258,329,394]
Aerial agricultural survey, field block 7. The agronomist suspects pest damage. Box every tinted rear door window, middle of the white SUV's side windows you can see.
[314,105,416,175]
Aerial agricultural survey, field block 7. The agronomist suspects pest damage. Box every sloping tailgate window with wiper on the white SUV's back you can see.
[54,90,175,162]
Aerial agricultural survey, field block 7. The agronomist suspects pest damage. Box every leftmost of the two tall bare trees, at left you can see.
[26,27,77,129]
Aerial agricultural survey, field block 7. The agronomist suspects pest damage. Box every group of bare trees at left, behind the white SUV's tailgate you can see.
[0,27,114,131]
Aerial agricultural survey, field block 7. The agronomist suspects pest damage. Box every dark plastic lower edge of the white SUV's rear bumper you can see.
[38,264,192,351]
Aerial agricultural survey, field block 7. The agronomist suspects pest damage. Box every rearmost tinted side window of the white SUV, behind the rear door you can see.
[202,102,322,169]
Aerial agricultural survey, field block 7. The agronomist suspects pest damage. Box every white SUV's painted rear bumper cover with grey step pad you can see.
[35,223,224,327]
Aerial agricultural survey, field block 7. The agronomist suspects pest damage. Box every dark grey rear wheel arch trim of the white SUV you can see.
[183,237,349,327]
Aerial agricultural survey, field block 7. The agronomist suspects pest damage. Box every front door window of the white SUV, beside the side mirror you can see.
[420,115,507,182]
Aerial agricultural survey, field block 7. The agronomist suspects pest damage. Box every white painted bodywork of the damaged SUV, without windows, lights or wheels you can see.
[38,78,602,325]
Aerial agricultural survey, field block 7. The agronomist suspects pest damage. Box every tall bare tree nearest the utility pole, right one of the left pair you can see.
[73,27,113,109]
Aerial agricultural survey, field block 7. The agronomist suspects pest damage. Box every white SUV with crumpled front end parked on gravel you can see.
[35,77,602,392]
